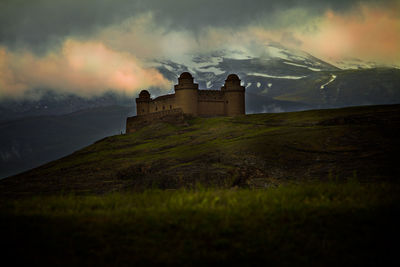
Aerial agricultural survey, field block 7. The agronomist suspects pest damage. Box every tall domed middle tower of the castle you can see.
[175,72,199,115]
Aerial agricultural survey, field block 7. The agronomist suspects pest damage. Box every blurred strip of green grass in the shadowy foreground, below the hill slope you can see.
[0,183,400,266]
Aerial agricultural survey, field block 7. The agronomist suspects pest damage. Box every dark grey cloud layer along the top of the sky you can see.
[0,0,397,50]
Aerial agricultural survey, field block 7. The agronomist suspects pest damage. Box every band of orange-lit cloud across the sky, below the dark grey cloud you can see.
[0,4,400,98]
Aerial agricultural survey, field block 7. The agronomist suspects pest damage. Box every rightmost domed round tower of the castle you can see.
[221,74,245,116]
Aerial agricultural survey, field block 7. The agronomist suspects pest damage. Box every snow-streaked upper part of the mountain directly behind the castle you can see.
[156,44,339,89]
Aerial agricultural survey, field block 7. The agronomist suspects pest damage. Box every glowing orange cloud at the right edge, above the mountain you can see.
[299,5,400,65]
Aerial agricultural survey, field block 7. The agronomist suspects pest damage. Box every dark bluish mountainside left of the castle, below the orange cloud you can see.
[0,106,132,178]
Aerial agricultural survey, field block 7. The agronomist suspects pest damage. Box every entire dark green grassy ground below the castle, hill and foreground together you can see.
[0,105,400,266]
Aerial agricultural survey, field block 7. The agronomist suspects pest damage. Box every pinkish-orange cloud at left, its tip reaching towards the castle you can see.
[0,40,170,97]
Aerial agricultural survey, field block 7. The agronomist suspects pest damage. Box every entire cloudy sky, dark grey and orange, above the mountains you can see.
[0,0,400,98]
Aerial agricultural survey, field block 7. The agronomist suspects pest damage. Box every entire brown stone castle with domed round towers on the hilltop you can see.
[126,72,245,133]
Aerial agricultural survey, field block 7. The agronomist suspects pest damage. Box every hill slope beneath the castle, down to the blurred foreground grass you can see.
[0,105,400,197]
